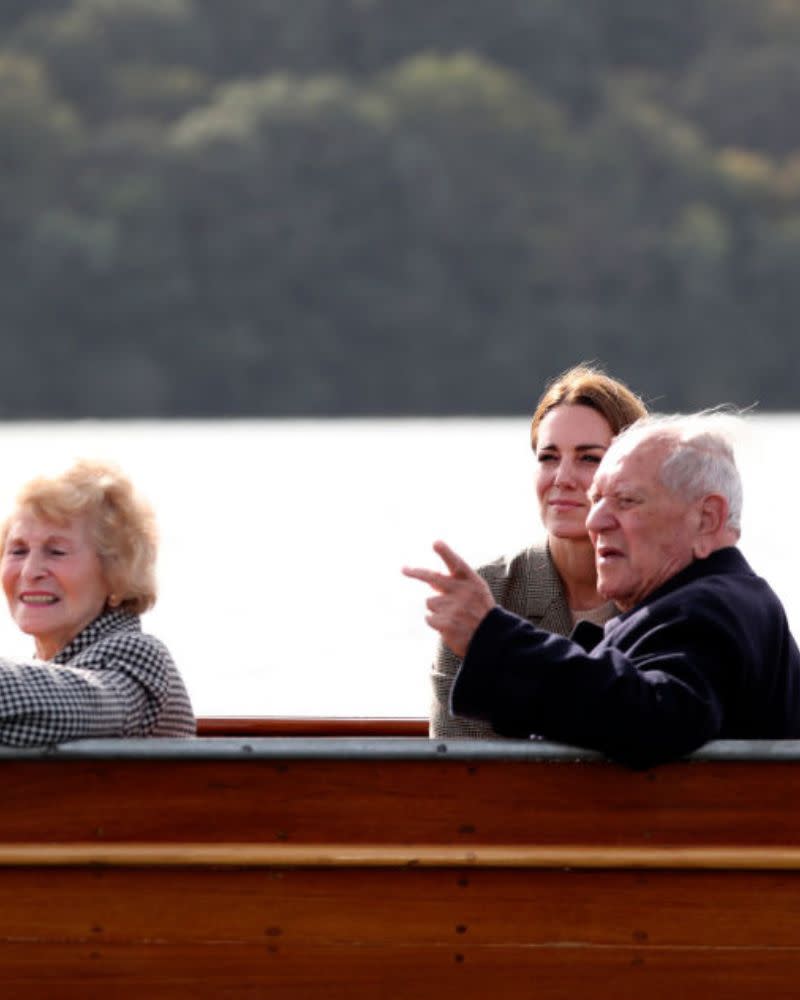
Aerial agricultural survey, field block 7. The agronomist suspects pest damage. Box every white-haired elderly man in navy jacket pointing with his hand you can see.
[404,415,800,767]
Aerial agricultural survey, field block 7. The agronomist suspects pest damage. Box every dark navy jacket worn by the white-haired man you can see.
[451,548,800,767]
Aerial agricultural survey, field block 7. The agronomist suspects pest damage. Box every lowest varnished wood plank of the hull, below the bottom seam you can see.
[3,944,797,1000]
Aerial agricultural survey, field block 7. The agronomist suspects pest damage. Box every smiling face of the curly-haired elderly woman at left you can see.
[0,510,108,659]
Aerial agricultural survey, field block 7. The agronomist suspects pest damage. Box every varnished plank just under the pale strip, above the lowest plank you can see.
[0,869,800,953]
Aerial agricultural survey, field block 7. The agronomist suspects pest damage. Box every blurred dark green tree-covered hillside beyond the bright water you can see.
[0,0,800,418]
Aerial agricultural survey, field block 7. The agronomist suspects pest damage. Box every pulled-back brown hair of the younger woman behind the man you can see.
[531,364,647,451]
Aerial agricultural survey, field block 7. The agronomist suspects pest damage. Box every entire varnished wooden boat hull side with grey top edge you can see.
[0,738,800,1000]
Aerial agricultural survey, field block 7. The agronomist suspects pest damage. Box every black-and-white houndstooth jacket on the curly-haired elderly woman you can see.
[0,609,195,746]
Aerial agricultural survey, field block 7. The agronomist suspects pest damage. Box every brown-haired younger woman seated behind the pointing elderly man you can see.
[430,365,647,739]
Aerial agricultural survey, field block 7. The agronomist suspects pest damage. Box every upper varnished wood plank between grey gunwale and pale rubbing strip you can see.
[0,759,800,846]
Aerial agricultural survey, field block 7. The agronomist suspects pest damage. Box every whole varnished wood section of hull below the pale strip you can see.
[0,869,800,1000]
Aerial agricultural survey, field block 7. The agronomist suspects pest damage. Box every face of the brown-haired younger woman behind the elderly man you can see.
[536,405,612,539]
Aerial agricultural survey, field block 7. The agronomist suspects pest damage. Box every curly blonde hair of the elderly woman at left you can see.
[0,459,158,614]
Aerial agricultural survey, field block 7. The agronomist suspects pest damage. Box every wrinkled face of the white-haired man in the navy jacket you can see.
[587,440,700,611]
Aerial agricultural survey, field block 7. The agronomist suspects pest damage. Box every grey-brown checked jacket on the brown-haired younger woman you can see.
[429,545,616,740]
